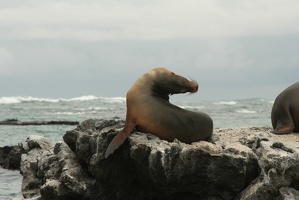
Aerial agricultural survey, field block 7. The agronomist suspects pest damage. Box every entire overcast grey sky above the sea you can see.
[0,0,299,100]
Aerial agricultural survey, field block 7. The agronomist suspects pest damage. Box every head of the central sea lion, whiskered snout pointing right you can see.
[152,68,198,96]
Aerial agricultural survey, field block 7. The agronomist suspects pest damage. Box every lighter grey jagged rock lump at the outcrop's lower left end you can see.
[20,136,95,200]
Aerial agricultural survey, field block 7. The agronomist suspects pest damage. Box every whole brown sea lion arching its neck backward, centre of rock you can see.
[105,68,213,158]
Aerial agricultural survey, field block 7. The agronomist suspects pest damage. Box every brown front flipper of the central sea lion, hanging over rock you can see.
[105,119,136,158]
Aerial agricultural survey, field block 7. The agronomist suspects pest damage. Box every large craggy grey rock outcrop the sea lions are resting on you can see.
[20,119,299,200]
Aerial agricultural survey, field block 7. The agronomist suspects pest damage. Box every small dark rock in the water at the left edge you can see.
[0,145,22,170]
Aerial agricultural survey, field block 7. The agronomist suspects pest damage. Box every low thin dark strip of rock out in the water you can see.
[0,119,79,126]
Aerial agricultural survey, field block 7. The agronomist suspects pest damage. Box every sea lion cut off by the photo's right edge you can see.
[271,82,299,134]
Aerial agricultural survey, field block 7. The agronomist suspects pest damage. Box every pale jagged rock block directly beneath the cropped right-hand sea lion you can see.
[240,128,299,200]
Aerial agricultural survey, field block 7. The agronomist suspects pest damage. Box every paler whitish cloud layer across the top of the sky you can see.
[0,0,299,41]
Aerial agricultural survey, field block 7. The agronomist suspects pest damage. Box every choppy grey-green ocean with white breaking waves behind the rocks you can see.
[0,96,273,200]
